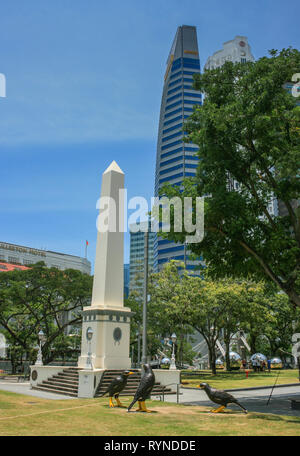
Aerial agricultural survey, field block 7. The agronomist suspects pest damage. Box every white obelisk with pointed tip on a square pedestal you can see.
[78,161,132,369]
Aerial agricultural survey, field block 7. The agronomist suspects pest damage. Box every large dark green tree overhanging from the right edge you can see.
[161,49,300,306]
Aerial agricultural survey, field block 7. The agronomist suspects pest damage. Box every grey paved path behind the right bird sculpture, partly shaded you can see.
[154,384,300,416]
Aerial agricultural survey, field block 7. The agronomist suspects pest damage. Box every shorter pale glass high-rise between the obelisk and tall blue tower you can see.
[129,222,155,299]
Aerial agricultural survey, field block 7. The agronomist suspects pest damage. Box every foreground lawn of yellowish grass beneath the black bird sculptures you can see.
[0,391,300,436]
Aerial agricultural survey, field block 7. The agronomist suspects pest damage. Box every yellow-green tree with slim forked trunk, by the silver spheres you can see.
[184,270,271,374]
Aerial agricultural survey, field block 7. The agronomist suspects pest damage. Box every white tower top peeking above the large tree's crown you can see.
[204,35,255,70]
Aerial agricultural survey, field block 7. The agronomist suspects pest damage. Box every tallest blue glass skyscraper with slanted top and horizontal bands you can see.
[154,25,202,271]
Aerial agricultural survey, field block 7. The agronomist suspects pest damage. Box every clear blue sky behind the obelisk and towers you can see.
[0,0,300,261]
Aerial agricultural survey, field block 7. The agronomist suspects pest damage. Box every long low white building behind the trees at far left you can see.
[0,241,91,274]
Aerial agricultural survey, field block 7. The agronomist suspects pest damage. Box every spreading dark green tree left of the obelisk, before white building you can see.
[0,262,92,368]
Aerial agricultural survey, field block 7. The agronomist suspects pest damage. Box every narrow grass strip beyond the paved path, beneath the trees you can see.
[182,369,299,389]
